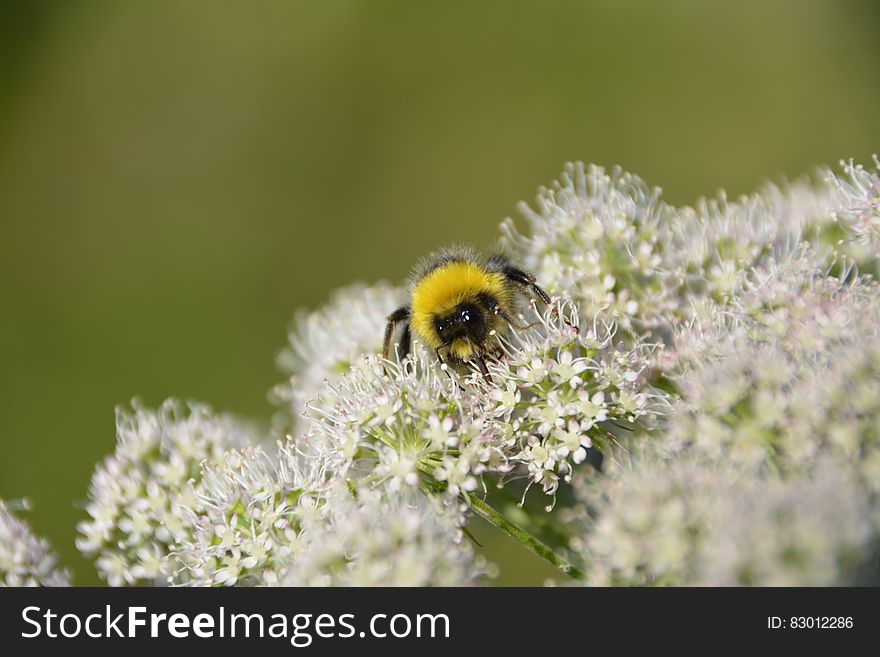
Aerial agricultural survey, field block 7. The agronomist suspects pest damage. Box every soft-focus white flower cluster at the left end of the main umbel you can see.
[77,400,252,586]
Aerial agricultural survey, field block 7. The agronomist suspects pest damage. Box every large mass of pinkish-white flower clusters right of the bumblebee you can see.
[504,158,880,585]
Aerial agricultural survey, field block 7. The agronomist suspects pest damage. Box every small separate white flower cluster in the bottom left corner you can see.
[0,500,70,587]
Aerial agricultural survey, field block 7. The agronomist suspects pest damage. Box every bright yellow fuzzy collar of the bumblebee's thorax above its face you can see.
[410,262,508,355]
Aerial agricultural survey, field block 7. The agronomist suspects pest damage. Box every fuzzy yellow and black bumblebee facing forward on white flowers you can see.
[383,247,550,380]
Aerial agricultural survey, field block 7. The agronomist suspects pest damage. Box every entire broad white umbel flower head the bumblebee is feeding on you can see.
[55,158,880,586]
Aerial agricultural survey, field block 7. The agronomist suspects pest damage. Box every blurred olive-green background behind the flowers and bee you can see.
[0,0,880,584]
